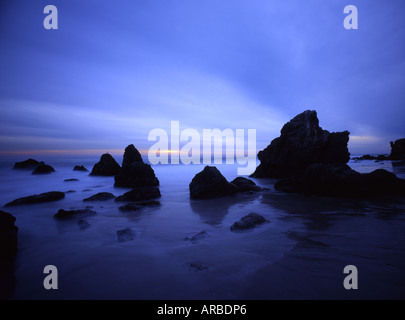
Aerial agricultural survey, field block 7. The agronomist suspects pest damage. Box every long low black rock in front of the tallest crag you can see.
[275,163,405,197]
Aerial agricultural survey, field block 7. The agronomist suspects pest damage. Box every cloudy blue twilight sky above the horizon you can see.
[0,0,405,156]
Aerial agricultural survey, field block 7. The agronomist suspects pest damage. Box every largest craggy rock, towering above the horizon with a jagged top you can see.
[252,110,350,178]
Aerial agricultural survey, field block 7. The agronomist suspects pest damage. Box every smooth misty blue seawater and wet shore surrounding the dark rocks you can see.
[0,158,405,299]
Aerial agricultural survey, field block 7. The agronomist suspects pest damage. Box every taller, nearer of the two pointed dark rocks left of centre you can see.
[114,144,159,188]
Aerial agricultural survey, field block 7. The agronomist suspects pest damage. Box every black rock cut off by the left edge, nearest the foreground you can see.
[0,210,18,264]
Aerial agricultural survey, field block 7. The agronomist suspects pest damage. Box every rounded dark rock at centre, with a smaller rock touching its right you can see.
[189,166,237,199]
